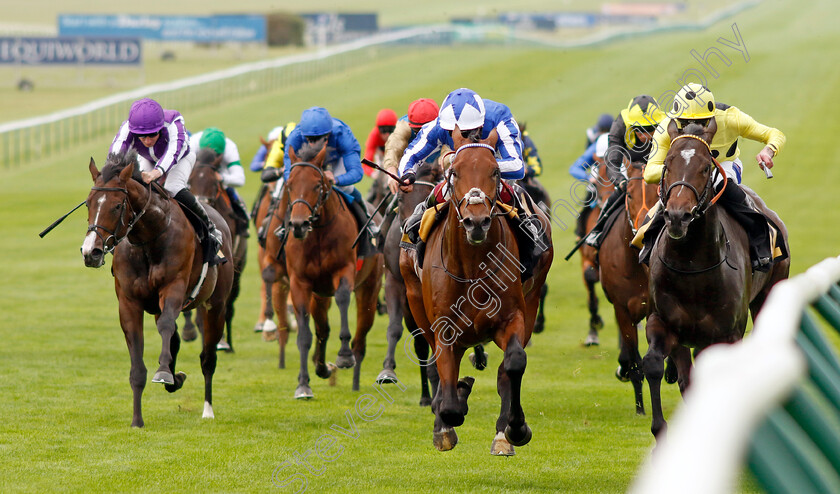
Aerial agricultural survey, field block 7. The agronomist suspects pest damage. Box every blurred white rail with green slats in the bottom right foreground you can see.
[630,258,840,494]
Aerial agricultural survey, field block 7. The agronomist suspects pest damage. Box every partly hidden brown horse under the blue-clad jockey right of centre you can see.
[577,157,615,346]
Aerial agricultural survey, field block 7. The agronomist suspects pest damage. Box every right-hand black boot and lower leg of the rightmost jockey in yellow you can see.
[718,182,773,272]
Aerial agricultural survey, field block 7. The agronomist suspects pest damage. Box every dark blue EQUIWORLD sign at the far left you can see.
[0,38,143,65]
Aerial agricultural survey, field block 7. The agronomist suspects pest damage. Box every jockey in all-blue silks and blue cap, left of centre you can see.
[262,106,379,257]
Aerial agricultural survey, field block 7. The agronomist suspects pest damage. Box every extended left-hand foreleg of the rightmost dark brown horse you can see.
[642,312,675,441]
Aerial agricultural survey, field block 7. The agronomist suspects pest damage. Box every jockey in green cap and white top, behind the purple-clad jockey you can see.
[190,127,248,237]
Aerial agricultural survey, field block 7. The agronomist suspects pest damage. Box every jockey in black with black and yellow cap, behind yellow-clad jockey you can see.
[586,94,665,249]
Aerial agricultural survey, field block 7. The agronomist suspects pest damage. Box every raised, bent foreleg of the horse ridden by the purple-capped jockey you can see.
[152,283,186,393]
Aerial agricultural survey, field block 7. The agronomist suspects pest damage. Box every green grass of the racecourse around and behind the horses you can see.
[0,0,840,493]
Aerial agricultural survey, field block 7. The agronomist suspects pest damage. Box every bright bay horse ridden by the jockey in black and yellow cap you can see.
[598,163,659,415]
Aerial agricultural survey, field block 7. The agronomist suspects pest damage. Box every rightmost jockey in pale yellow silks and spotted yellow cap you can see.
[639,83,786,271]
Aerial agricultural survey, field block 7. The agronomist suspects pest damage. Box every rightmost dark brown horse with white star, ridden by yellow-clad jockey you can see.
[642,119,790,441]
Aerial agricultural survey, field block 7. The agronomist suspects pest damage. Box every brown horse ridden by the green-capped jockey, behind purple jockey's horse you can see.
[182,148,248,352]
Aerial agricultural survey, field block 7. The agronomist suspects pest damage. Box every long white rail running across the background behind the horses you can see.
[0,0,760,169]
